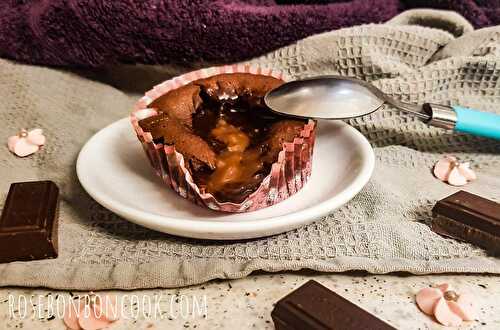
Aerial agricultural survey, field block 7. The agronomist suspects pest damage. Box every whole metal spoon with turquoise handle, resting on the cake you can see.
[264,76,500,139]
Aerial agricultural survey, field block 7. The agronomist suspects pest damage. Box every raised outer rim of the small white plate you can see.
[76,117,375,240]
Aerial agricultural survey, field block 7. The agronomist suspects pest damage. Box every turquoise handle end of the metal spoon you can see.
[453,106,500,140]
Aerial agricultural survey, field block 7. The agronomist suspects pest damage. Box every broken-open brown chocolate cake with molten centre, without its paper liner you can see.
[139,73,306,203]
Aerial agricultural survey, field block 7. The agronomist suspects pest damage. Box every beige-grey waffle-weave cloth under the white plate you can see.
[0,10,500,289]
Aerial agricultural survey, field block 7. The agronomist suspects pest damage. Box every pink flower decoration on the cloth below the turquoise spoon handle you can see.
[433,156,477,186]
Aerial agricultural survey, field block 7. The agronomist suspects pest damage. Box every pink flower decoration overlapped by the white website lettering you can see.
[63,294,118,330]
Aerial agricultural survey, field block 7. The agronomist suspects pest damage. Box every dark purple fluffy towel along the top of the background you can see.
[0,0,500,67]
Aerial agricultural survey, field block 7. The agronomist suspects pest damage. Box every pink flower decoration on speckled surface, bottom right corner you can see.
[415,283,476,327]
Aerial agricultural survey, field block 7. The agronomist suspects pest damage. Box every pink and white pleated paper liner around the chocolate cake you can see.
[130,64,315,212]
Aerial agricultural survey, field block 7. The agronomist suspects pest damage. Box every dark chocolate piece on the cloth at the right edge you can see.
[432,191,500,255]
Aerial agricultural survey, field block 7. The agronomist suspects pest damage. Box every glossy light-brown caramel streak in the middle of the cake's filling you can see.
[206,119,264,192]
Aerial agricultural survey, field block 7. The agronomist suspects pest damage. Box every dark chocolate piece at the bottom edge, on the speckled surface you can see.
[271,281,395,330]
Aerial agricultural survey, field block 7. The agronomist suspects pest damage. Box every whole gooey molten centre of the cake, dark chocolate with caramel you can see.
[184,88,303,203]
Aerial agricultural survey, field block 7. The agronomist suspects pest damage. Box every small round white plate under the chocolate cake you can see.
[76,118,375,239]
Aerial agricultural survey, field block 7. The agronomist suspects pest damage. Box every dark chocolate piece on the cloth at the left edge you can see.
[0,181,59,262]
